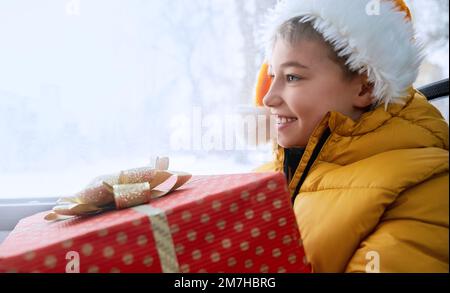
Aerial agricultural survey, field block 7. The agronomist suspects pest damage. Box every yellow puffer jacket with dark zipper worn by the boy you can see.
[257,89,449,272]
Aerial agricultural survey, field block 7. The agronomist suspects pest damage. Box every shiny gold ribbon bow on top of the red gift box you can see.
[45,158,192,221]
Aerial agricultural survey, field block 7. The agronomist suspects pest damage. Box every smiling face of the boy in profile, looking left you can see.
[264,39,368,148]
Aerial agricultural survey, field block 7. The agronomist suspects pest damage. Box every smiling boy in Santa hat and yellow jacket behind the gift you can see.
[256,0,449,272]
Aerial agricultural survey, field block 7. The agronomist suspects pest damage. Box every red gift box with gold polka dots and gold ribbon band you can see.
[0,173,311,273]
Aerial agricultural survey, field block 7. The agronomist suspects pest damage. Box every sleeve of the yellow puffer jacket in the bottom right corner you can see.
[346,172,449,273]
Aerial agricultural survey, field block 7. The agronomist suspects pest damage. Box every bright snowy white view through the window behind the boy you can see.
[0,0,449,198]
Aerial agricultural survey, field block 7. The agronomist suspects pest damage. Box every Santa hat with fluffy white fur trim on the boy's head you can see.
[255,0,424,106]
